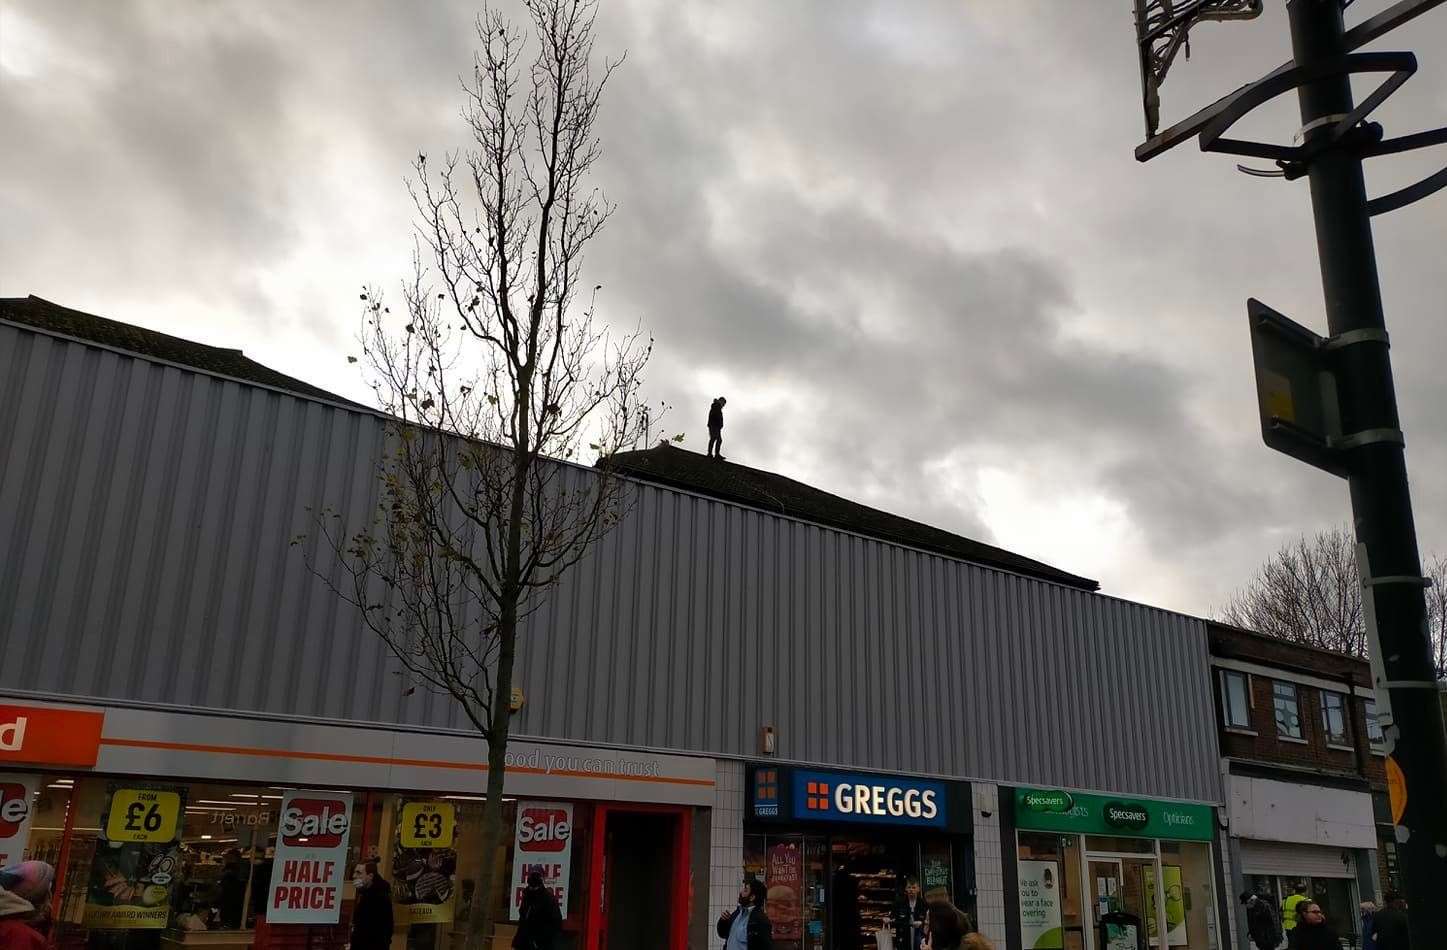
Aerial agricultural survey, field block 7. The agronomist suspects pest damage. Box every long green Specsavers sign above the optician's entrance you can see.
[1014,788,1215,842]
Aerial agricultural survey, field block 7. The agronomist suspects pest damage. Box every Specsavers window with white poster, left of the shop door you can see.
[1017,831,1087,950]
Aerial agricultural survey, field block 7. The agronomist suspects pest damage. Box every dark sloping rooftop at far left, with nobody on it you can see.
[0,295,360,408]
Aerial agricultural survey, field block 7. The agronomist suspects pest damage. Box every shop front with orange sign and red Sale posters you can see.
[0,703,715,950]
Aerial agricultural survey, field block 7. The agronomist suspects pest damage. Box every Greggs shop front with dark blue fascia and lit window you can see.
[744,763,974,950]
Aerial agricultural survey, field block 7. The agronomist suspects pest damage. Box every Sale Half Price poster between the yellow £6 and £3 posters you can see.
[266,789,352,924]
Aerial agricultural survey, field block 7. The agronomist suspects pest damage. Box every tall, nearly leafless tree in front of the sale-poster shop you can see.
[313,0,665,950]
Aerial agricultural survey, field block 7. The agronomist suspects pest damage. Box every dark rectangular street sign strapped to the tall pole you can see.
[1246,298,1347,479]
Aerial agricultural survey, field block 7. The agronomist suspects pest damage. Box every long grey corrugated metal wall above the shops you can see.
[0,325,1220,800]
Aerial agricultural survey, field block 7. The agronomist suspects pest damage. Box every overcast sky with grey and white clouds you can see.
[0,0,1447,615]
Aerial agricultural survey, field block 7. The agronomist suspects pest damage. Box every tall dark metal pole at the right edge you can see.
[1286,0,1447,950]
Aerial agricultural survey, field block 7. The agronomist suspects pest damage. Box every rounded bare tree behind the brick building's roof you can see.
[1218,526,1447,677]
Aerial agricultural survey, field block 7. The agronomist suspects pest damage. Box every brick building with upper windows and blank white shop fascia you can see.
[1208,623,1396,947]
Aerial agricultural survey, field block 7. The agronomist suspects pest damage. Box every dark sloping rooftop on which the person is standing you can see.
[599,444,1100,591]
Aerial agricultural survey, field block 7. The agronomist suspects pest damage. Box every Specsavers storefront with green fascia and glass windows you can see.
[1006,788,1227,950]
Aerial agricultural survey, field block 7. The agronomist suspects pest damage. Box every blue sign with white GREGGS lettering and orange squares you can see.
[790,769,946,829]
